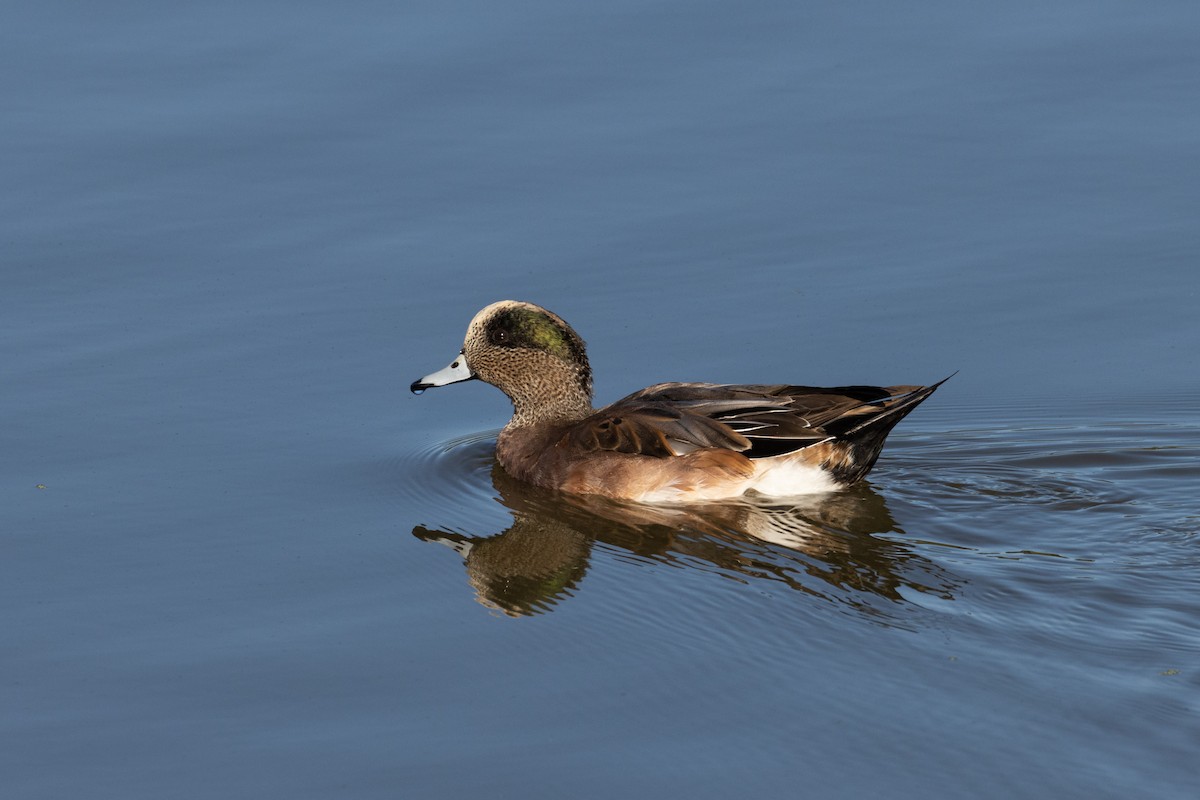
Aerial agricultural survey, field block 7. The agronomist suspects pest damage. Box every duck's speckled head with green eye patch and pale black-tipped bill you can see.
[412,300,592,416]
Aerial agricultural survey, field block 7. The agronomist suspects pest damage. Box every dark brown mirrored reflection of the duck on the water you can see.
[413,465,956,616]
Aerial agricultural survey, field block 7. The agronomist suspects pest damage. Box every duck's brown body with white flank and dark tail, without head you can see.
[497,381,943,501]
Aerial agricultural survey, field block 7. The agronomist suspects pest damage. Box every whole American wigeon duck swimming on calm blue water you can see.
[412,300,944,503]
